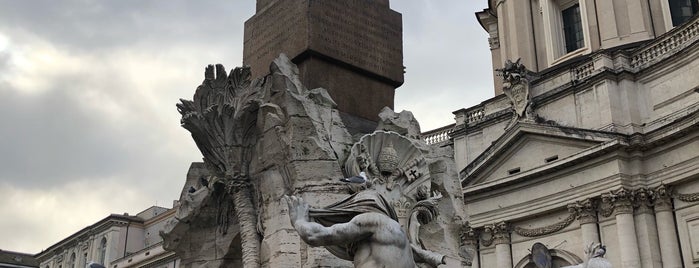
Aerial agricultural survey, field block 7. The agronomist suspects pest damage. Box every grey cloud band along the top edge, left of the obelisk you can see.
[0,0,254,50]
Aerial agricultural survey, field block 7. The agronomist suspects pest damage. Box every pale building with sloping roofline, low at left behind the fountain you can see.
[35,206,179,268]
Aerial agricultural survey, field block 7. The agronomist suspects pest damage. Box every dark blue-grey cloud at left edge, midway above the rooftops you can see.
[0,87,134,187]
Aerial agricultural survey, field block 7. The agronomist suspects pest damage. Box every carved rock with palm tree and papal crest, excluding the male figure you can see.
[163,54,466,267]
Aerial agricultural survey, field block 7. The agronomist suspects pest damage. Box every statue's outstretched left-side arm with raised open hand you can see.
[284,196,373,247]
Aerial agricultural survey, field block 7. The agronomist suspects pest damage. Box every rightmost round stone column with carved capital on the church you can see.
[653,185,682,268]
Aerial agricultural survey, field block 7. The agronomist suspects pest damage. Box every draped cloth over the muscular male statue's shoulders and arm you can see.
[308,191,398,261]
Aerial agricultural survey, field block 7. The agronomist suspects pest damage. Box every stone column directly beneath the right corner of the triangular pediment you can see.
[602,188,641,268]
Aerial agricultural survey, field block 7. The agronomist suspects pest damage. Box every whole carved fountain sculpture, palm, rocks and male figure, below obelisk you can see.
[162,54,467,268]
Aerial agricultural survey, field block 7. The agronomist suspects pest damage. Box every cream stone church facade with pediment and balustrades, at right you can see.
[418,0,699,268]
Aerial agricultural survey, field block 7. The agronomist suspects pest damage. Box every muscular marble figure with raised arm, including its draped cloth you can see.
[284,191,445,268]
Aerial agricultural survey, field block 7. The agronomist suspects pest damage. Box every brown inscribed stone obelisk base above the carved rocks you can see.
[243,0,404,128]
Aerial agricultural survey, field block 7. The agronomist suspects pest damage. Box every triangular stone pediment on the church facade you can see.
[461,122,620,187]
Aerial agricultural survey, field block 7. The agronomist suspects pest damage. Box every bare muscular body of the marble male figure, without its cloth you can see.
[285,196,445,268]
